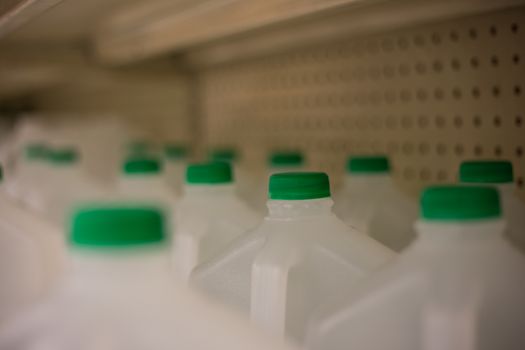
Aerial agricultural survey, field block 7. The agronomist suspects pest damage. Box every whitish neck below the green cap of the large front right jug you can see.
[414,218,506,250]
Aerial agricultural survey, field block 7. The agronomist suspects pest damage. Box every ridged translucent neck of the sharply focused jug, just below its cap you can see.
[267,198,334,219]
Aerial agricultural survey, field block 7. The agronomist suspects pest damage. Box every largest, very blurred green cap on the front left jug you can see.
[70,206,166,247]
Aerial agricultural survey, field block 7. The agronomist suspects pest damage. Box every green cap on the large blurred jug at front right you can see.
[420,185,501,221]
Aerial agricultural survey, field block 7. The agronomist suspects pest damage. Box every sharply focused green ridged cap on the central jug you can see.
[268,172,330,200]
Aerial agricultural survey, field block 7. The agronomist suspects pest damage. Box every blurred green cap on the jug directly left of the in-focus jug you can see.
[186,162,233,185]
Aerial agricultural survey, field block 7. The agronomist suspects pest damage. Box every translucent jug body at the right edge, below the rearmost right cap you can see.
[498,184,525,252]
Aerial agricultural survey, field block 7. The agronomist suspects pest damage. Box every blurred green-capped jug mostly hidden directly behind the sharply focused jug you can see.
[250,151,304,214]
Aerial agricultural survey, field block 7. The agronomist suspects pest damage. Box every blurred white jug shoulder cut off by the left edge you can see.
[0,167,64,327]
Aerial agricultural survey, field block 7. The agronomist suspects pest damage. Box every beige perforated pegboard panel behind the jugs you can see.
[199,7,525,195]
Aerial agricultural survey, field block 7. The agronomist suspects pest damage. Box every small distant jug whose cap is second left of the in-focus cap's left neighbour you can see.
[163,144,188,194]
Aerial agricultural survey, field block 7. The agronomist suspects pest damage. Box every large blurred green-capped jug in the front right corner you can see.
[307,186,525,350]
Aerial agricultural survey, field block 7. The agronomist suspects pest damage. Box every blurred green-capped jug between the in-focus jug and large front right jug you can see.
[335,156,417,251]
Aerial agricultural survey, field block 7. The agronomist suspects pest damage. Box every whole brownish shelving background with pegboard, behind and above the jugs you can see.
[0,0,525,196]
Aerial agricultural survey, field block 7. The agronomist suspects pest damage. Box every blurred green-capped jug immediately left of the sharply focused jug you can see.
[174,162,260,280]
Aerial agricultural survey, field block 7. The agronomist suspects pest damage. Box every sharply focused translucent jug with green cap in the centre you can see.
[192,172,394,341]
